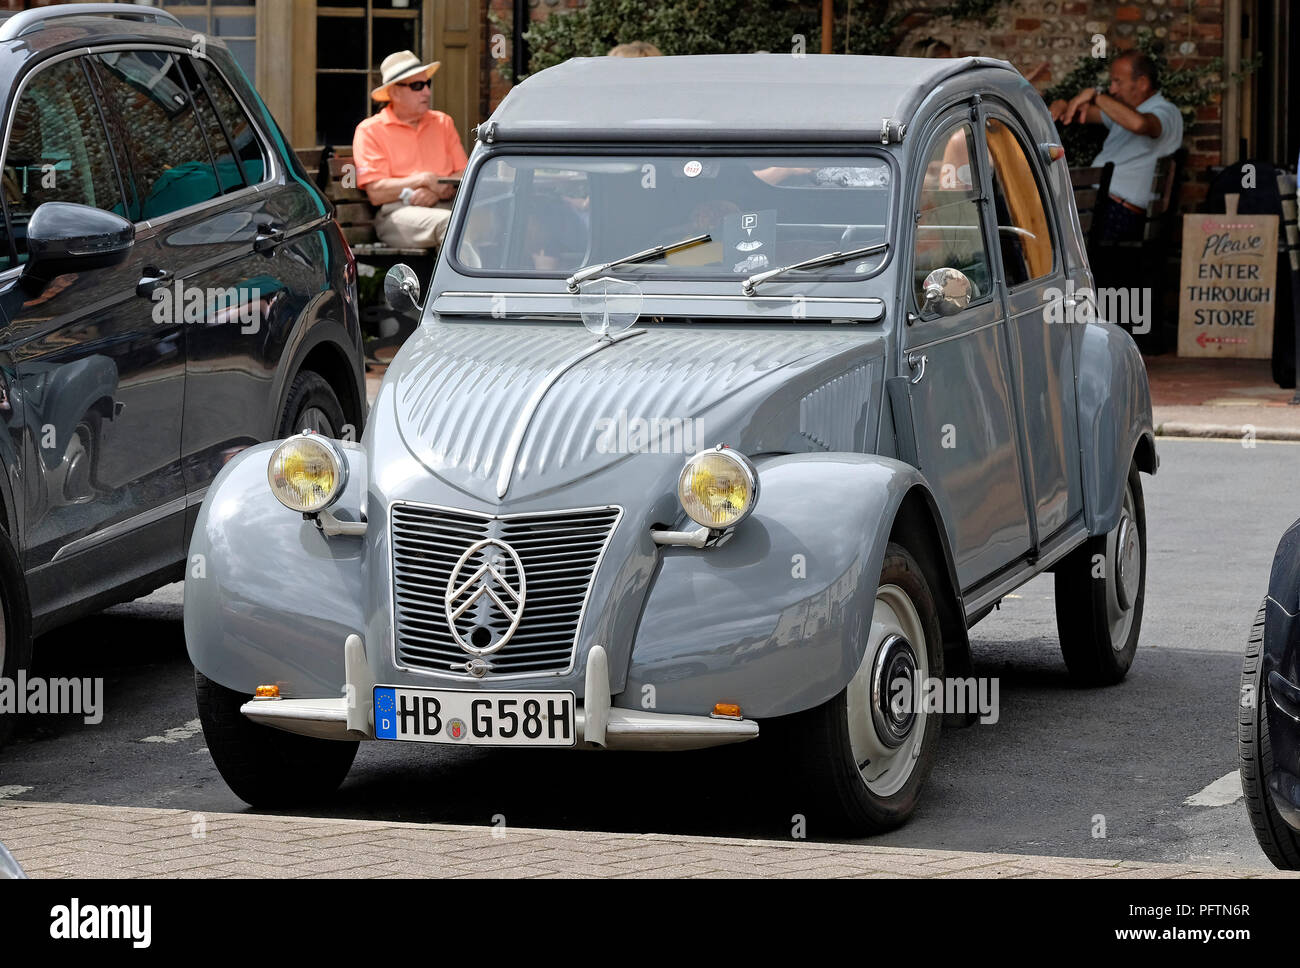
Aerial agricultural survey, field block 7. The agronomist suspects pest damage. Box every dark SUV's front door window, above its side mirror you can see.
[4,58,125,268]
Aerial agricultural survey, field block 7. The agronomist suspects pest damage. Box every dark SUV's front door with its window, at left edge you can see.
[0,57,185,617]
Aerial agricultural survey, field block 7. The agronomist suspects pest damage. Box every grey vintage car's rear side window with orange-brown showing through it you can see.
[984,118,1053,287]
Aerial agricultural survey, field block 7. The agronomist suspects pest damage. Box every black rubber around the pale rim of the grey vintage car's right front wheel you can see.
[762,542,944,837]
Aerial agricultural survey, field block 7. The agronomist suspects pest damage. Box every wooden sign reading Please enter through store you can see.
[1178,195,1278,360]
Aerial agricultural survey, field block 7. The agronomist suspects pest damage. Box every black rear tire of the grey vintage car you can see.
[1056,464,1147,686]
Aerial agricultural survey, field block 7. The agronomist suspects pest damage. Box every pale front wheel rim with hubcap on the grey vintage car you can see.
[846,585,930,796]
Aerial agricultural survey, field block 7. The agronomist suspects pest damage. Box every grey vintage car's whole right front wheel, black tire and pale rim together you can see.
[764,542,944,835]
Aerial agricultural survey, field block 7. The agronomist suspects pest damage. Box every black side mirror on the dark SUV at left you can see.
[20,201,135,294]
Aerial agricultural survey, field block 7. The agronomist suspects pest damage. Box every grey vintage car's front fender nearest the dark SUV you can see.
[185,443,367,696]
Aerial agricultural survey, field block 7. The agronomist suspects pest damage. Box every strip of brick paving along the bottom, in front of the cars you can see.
[0,800,1300,878]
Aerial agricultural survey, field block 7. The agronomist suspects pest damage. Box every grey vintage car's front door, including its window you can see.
[901,107,1031,591]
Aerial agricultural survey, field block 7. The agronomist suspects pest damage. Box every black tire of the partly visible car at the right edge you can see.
[1236,605,1300,871]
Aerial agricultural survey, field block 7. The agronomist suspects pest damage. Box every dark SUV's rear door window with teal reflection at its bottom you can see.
[94,51,224,221]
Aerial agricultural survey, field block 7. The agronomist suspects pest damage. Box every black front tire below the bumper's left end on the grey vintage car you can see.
[194,669,360,807]
